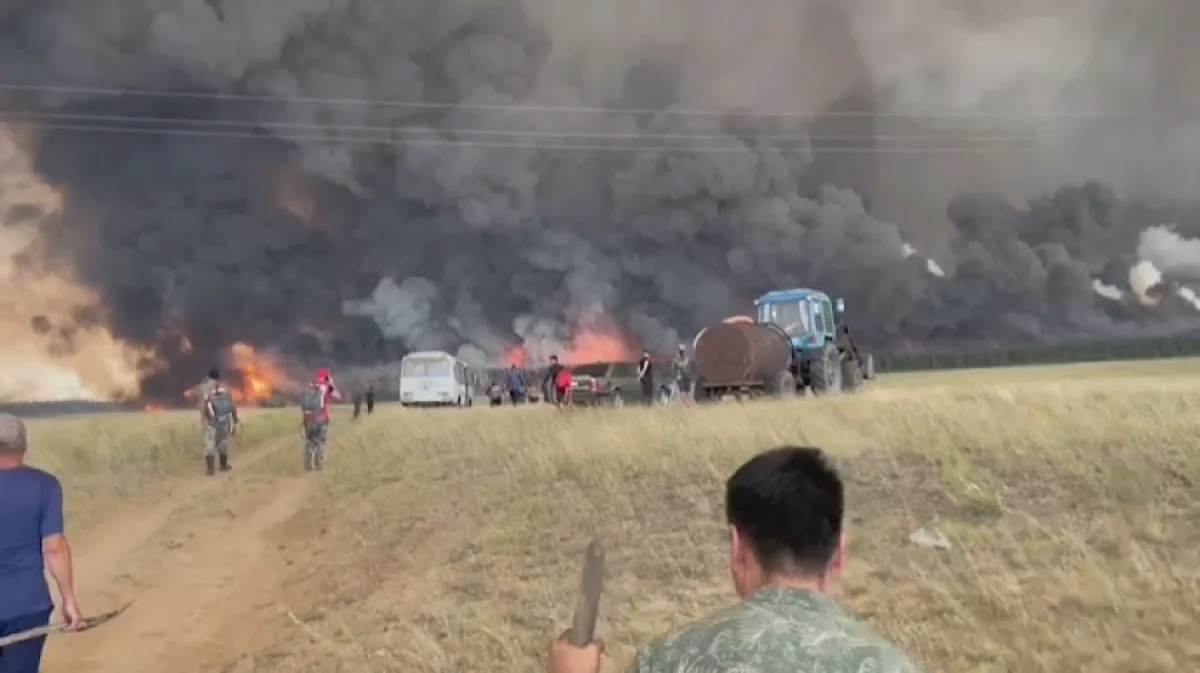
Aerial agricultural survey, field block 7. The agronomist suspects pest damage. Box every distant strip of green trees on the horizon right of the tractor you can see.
[875,338,1200,372]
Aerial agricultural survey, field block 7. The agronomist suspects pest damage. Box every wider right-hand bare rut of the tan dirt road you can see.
[47,477,311,673]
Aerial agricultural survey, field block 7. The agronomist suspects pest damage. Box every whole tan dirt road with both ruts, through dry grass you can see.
[44,443,319,673]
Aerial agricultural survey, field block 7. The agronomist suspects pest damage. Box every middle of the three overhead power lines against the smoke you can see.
[0,110,1034,143]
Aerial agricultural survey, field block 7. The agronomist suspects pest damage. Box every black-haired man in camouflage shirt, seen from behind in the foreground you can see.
[547,446,918,673]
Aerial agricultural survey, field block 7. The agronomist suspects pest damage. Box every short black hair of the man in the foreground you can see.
[725,446,845,575]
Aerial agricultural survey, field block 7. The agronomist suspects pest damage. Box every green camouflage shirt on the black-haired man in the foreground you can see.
[629,587,919,673]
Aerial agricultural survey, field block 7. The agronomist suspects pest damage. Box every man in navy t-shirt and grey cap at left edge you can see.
[0,414,83,673]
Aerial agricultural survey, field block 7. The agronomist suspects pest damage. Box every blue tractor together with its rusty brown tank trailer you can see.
[694,288,875,399]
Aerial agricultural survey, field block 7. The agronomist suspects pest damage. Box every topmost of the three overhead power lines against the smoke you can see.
[0,83,1177,119]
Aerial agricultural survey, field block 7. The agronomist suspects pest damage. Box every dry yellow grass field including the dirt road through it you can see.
[18,361,1200,673]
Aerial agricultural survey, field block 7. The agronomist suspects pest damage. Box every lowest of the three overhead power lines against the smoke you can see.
[0,116,1038,155]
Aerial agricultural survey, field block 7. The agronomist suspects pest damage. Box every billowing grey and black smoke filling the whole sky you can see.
[0,0,1200,399]
